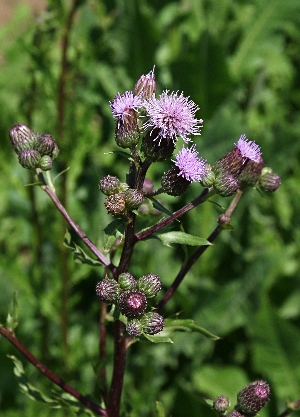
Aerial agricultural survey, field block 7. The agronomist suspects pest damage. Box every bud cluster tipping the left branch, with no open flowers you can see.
[9,123,59,171]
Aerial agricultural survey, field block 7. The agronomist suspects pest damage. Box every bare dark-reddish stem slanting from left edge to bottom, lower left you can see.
[0,326,109,417]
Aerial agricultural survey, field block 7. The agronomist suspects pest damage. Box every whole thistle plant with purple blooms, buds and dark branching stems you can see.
[1,66,292,417]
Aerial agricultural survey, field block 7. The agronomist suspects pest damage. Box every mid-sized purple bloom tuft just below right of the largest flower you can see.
[173,145,206,182]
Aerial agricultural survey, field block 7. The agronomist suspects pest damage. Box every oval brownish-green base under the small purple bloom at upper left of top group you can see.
[115,109,140,149]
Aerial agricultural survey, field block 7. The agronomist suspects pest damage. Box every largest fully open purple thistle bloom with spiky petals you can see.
[143,90,203,143]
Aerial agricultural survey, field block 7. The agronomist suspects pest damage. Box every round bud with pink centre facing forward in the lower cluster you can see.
[118,290,147,318]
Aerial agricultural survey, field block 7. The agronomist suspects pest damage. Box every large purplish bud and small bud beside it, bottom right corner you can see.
[213,381,270,417]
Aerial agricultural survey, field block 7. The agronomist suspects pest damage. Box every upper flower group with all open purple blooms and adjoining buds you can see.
[100,71,280,214]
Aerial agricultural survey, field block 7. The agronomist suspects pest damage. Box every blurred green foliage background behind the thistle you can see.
[0,0,300,417]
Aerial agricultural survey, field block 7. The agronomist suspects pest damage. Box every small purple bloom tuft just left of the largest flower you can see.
[109,91,142,123]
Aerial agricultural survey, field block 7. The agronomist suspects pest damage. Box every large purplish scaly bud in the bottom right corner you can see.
[235,381,270,416]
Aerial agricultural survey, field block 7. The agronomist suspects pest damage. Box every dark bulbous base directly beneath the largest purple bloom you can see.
[141,129,175,162]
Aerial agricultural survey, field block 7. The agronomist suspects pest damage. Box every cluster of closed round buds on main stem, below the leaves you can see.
[96,272,164,337]
